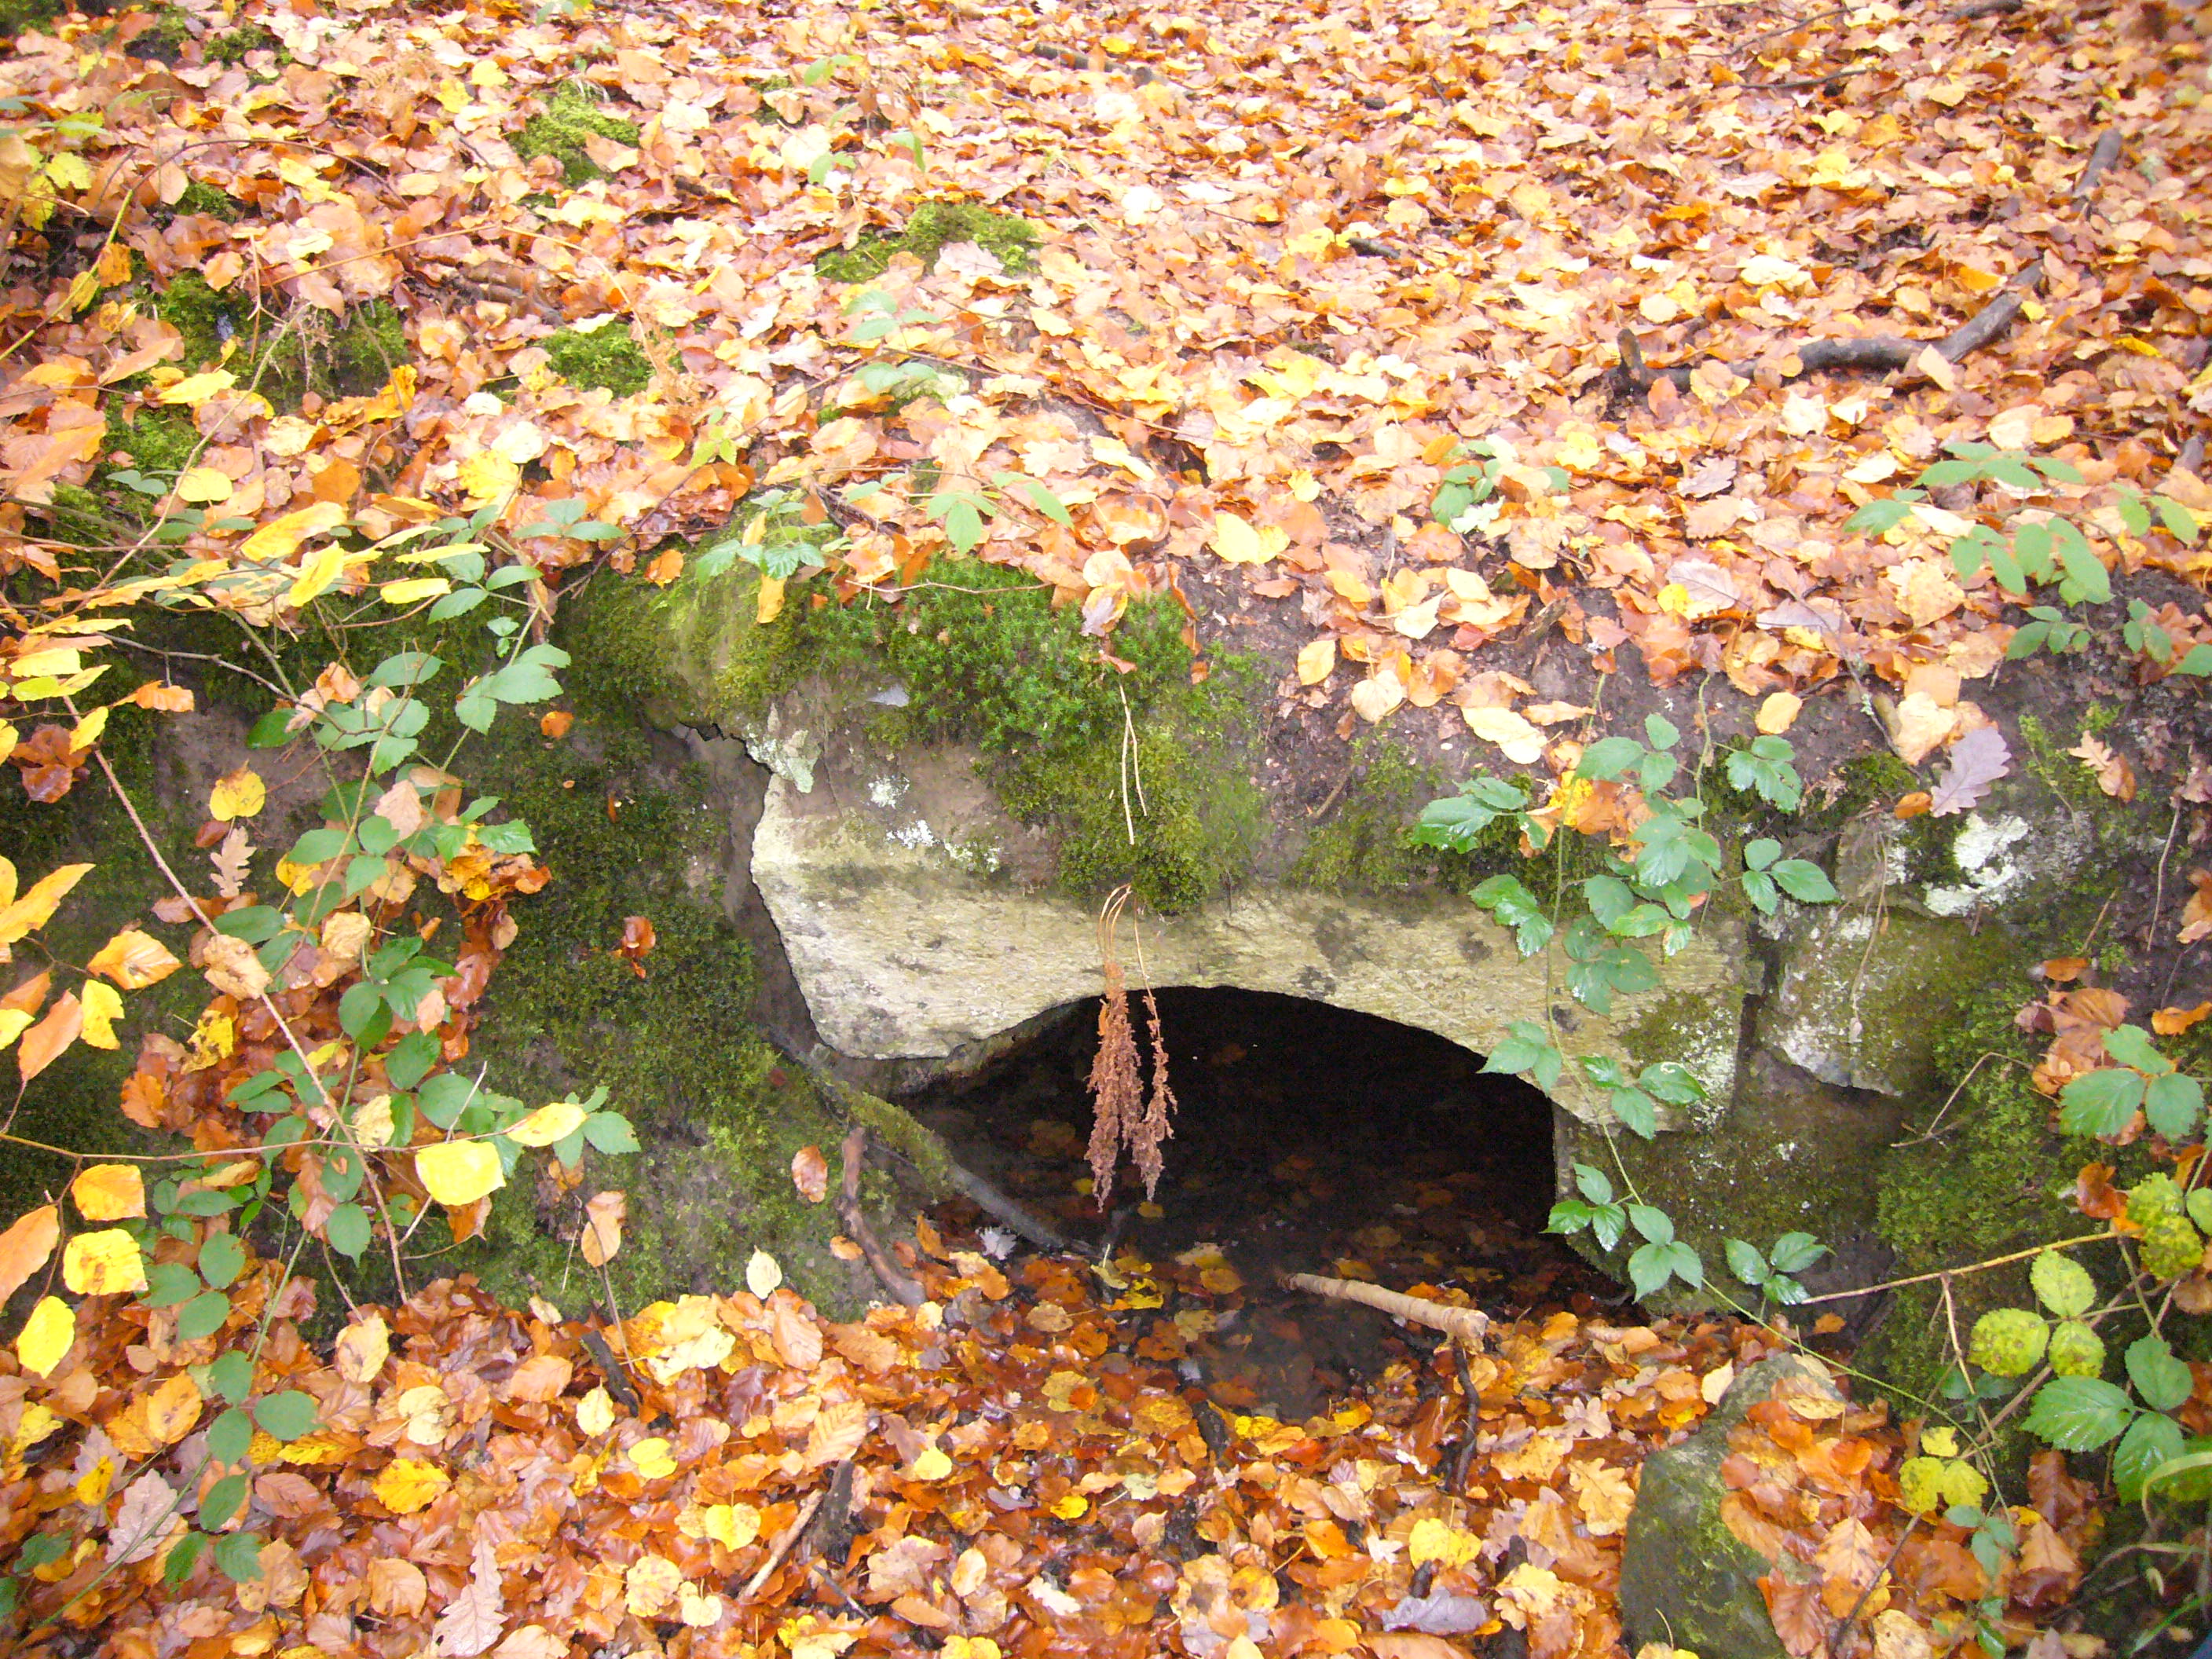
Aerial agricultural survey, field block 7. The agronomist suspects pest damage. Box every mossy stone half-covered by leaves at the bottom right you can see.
[1621,1353,1843,1659]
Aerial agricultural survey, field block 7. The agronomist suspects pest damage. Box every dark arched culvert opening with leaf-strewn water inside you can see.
[907,987,1626,1418]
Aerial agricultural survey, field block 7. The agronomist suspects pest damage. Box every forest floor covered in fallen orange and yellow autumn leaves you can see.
[0,0,2212,1659]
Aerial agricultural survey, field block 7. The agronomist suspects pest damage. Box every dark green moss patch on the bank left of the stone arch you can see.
[453,668,889,1314]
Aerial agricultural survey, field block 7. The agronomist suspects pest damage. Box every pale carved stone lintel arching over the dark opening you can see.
[752,765,1748,1112]
